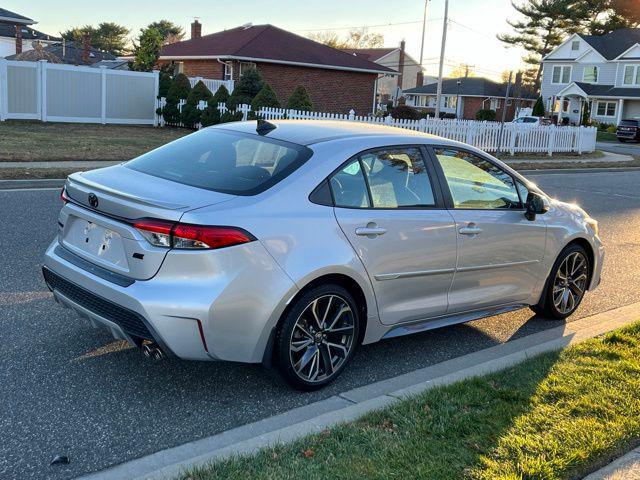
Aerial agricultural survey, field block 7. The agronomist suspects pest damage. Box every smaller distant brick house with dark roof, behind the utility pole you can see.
[403,77,536,121]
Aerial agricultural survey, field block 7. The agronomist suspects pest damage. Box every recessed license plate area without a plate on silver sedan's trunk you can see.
[62,215,129,273]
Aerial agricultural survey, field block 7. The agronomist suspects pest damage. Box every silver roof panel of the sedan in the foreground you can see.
[210,120,443,145]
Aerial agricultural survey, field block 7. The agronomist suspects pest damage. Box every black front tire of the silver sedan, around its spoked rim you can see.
[530,244,591,320]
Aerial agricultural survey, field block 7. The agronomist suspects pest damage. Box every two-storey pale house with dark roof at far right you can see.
[541,28,640,124]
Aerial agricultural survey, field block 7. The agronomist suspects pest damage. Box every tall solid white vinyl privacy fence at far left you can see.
[0,58,158,125]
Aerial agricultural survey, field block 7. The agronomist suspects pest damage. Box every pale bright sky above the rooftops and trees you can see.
[7,0,522,77]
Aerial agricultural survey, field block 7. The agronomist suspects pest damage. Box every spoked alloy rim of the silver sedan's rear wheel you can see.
[289,295,355,383]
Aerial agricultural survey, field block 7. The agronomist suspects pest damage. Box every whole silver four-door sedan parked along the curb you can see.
[43,121,604,390]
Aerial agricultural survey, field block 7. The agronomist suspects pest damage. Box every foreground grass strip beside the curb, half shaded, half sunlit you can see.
[182,323,640,480]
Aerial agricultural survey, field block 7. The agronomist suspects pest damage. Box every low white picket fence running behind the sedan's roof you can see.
[158,98,596,155]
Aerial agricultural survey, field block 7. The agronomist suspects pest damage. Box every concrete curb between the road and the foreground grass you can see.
[81,302,640,480]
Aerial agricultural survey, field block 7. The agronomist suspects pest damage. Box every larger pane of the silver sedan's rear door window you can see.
[360,148,435,208]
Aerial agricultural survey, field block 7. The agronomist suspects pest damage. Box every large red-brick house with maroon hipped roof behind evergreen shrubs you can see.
[159,20,398,115]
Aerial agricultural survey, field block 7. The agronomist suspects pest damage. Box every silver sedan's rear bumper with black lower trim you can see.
[43,239,295,362]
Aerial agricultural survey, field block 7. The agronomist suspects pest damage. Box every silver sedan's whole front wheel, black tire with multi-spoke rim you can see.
[531,245,590,319]
